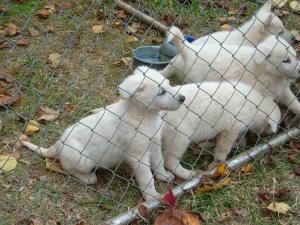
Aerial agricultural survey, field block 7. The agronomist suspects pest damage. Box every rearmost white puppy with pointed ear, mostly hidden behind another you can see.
[162,0,288,77]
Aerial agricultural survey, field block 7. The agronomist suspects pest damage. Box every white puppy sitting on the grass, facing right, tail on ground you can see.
[23,67,184,200]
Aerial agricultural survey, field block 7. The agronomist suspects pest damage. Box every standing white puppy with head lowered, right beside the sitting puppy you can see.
[162,82,281,179]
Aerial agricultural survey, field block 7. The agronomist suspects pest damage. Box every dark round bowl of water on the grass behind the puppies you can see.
[133,46,173,70]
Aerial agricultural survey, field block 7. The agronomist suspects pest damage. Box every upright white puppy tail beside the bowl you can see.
[167,26,188,60]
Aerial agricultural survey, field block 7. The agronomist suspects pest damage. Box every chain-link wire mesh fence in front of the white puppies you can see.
[0,0,300,224]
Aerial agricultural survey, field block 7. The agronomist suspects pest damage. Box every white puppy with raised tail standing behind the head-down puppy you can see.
[163,27,300,115]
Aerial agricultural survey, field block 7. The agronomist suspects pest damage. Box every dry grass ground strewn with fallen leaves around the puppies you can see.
[0,0,300,224]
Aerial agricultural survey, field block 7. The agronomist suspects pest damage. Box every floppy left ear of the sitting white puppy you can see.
[118,75,145,99]
